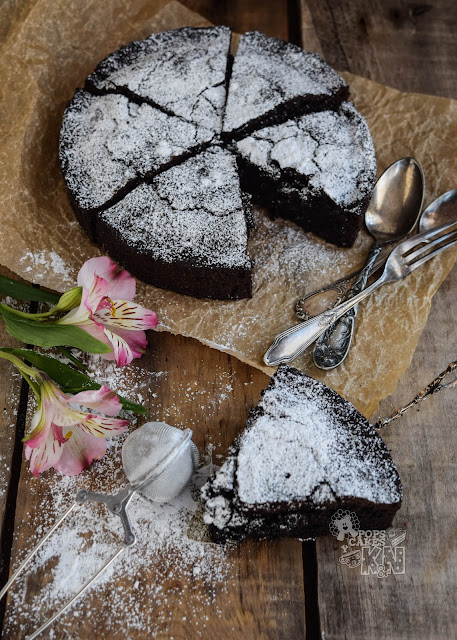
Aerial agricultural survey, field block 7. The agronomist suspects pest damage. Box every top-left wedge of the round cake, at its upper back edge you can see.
[86,27,231,133]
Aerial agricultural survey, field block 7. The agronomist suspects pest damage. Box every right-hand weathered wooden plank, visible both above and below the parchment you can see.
[303,0,457,640]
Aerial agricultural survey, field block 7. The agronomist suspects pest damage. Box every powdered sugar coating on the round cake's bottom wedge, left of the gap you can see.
[99,147,251,270]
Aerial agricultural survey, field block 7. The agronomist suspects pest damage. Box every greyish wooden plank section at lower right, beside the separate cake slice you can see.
[317,282,457,640]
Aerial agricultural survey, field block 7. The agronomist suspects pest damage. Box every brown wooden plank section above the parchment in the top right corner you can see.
[302,0,457,98]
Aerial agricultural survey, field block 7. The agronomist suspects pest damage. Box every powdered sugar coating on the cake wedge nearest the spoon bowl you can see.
[236,102,376,206]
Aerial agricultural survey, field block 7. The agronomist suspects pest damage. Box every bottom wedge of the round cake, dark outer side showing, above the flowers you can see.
[96,146,252,299]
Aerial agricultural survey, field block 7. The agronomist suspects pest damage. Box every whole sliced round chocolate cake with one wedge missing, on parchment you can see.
[59,27,376,299]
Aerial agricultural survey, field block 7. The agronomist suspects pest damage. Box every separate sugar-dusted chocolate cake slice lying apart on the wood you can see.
[202,365,402,541]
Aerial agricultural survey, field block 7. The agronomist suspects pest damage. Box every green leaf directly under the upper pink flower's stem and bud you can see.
[0,304,112,353]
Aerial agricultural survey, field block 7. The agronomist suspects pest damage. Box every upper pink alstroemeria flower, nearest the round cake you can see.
[57,256,157,367]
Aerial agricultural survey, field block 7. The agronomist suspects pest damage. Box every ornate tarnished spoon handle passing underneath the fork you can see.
[313,242,383,370]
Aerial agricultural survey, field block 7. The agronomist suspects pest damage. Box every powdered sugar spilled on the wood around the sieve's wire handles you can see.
[5,437,232,638]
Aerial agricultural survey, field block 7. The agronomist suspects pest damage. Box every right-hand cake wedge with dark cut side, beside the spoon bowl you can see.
[235,102,376,247]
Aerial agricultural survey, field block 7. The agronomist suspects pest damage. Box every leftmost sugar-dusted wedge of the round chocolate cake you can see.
[59,89,214,230]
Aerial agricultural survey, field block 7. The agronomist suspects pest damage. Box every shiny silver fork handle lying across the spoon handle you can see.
[263,272,391,367]
